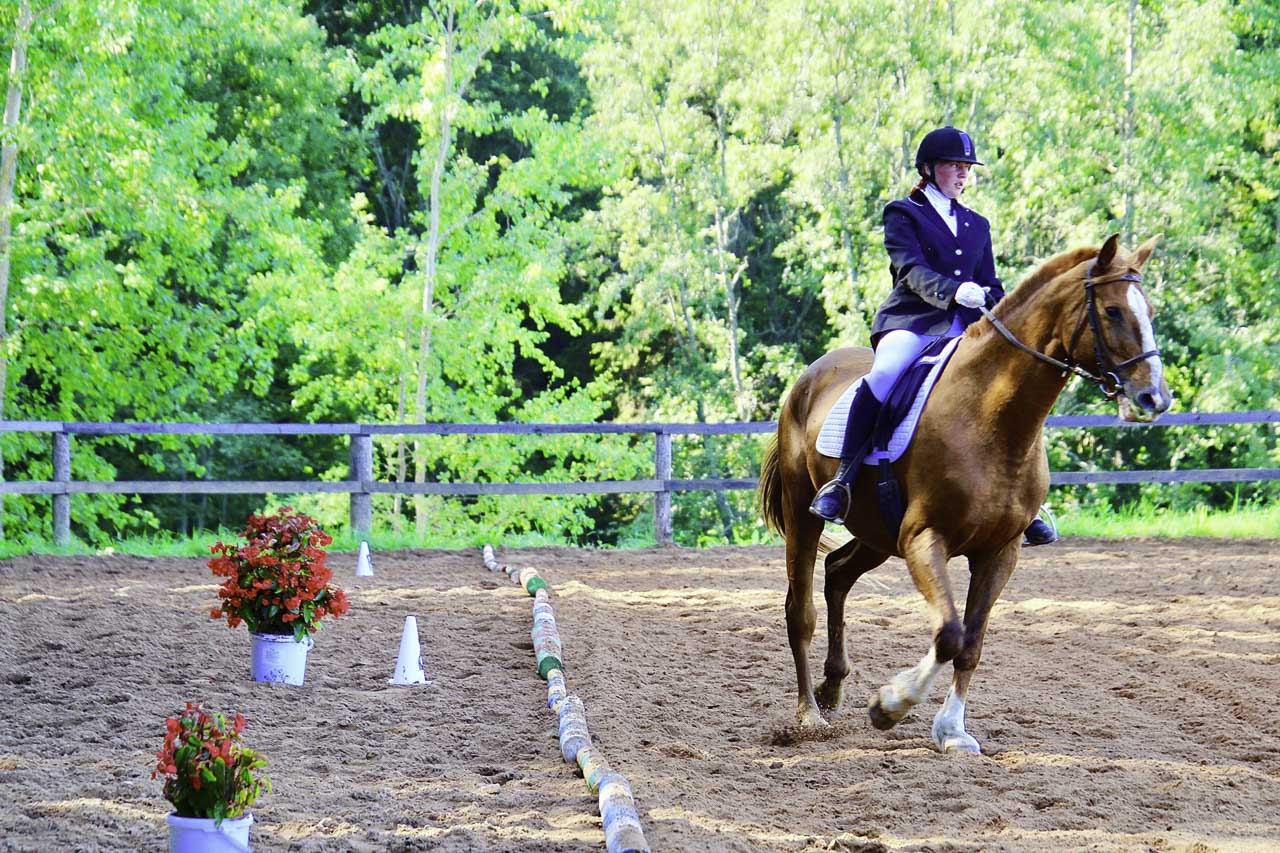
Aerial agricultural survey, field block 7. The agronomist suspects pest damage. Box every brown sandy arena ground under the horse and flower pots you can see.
[0,539,1280,853]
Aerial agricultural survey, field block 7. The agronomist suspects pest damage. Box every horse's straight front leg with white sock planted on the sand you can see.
[932,537,1021,754]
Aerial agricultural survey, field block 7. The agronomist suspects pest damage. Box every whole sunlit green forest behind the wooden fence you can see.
[0,0,1280,544]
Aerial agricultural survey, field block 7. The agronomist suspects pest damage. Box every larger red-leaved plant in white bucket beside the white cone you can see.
[209,506,349,684]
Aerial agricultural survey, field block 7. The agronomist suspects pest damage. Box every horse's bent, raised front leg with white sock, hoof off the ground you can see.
[867,528,965,729]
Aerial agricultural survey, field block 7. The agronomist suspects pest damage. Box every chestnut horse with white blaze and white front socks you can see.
[758,234,1172,753]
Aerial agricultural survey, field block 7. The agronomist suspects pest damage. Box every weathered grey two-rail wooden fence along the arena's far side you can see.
[0,411,1280,544]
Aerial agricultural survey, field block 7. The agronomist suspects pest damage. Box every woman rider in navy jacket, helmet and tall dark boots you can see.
[809,126,1057,546]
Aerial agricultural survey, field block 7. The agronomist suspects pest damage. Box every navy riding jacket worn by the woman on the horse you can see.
[872,190,1005,346]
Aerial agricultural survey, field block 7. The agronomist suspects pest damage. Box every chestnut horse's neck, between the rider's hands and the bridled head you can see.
[955,281,1079,450]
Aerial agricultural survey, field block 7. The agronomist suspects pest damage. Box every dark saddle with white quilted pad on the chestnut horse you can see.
[817,338,960,538]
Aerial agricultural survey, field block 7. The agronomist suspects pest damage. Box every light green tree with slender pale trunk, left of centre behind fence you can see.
[279,3,631,538]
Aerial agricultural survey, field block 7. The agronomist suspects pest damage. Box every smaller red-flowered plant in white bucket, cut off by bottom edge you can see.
[151,702,271,853]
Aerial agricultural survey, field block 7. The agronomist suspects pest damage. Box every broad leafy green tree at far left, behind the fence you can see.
[6,3,350,538]
